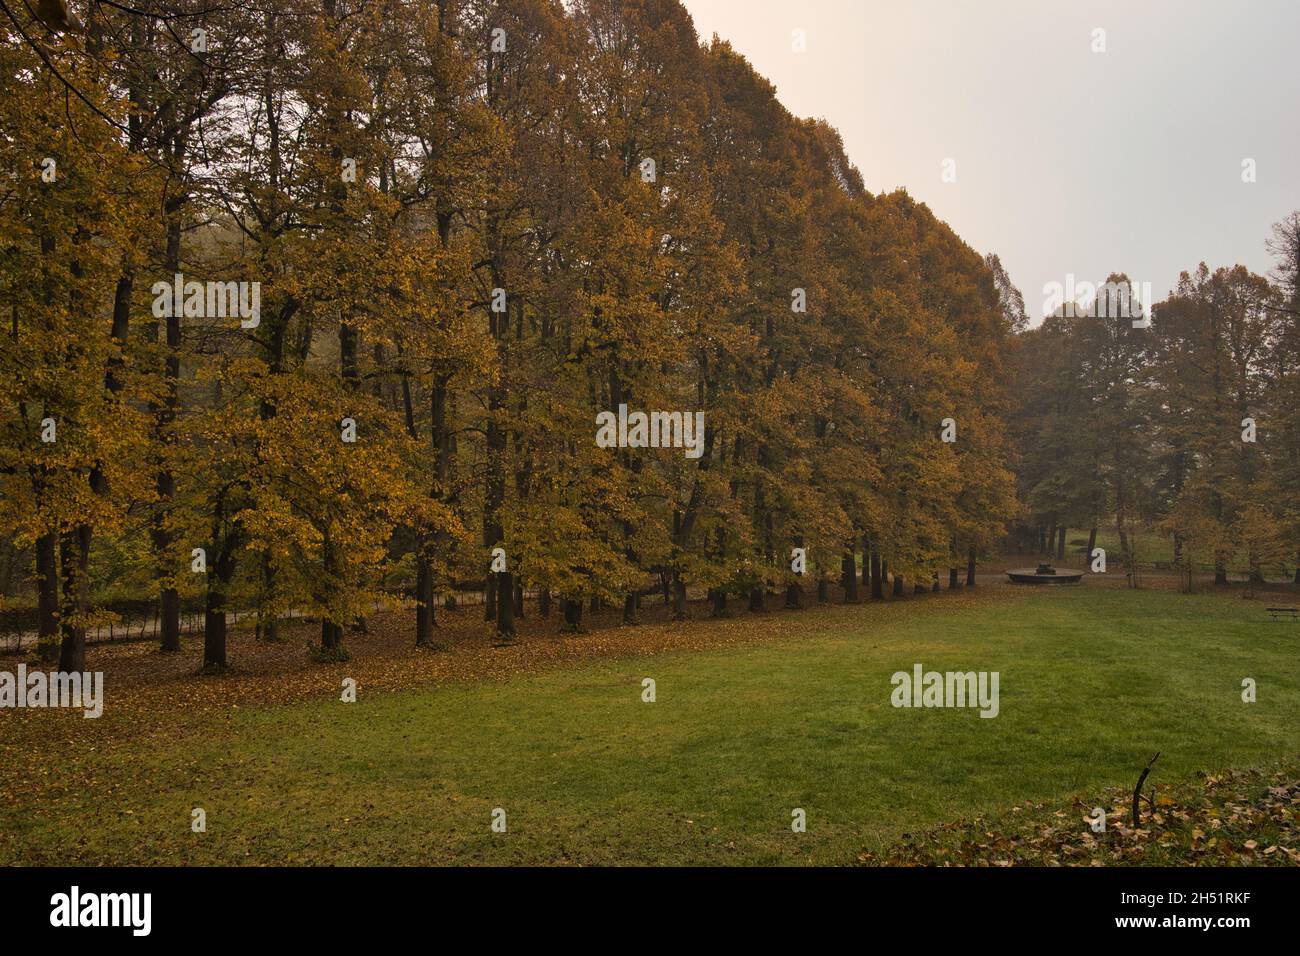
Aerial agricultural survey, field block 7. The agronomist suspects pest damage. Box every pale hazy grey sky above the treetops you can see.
[683,0,1300,321]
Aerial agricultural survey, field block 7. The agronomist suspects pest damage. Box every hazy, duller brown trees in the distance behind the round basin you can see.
[1013,212,1300,584]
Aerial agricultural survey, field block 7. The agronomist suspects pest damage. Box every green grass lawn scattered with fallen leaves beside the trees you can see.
[0,587,1300,864]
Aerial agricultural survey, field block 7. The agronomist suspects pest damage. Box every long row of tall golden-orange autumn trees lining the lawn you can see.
[0,0,1023,670]
